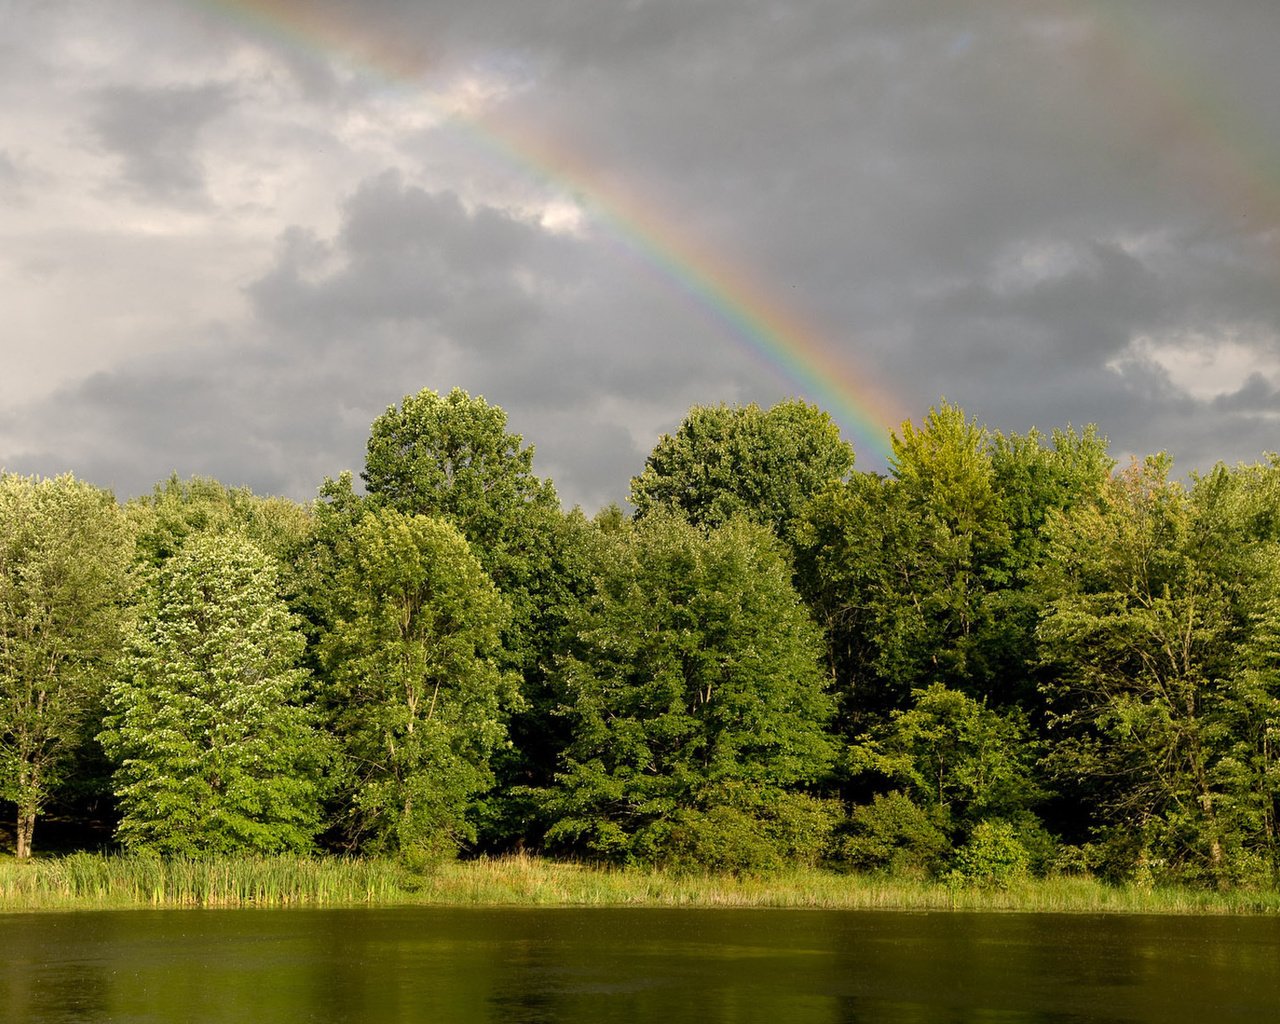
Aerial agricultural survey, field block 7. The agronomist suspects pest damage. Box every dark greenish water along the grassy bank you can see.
[0,908,1280,1024]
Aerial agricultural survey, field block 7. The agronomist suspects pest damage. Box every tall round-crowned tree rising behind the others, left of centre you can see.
[358,389,591,849]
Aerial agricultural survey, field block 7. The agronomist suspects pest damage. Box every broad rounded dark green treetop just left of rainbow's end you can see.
[631,399,854,543]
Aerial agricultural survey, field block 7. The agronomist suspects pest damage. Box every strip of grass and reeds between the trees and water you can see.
[0,854,1280,914]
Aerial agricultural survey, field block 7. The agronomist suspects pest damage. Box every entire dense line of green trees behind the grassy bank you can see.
[0,390,1280,887]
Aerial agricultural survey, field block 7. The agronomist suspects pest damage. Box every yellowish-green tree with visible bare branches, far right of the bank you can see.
[1039,456,1275,882]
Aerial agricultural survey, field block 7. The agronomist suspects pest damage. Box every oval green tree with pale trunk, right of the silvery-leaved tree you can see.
[321,508,518,855]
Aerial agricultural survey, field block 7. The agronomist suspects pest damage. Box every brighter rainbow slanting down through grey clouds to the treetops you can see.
[197,0,904,462]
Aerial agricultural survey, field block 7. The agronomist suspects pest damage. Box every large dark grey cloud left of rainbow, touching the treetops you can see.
[4,174,747,508]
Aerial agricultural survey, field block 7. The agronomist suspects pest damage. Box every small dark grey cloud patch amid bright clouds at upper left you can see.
[90,84,232,201]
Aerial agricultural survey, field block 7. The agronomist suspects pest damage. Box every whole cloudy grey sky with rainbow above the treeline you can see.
[0,0,1280,508]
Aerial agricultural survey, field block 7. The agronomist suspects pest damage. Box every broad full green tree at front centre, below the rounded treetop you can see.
[545,513,832,867]
